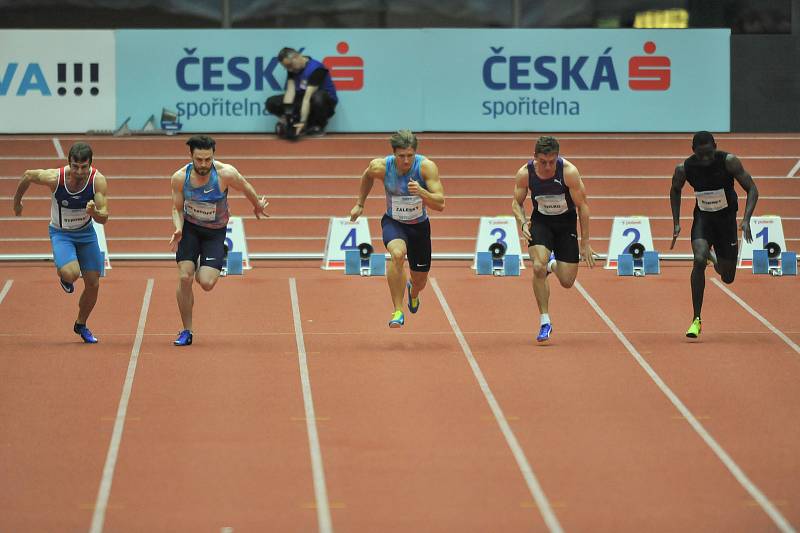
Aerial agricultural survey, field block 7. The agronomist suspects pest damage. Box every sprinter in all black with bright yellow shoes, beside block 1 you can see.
[669,131,758,339]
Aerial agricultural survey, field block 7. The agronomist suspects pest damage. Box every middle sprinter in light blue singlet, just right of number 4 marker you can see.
[350,130,444,328]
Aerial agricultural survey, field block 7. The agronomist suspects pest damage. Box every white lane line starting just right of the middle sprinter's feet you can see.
[431,278,563,532]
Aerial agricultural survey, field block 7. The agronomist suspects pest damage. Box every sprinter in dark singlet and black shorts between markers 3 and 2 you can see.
[511,137,595,342]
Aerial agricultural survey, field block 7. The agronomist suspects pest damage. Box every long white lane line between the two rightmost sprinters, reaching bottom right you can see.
[575,278,795,533]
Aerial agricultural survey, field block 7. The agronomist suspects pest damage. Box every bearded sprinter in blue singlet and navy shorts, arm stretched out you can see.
[169,135,269,346]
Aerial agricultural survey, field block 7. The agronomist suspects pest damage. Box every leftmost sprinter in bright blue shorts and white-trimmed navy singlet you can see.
[14,142,108,344]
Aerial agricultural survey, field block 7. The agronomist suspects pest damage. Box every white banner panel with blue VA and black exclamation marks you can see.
[0,30,117,132]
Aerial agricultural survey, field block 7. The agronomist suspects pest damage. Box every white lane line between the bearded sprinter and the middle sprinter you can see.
[289,278,333,533]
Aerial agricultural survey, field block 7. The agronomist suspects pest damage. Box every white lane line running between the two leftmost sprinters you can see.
[89,278,154,533]
